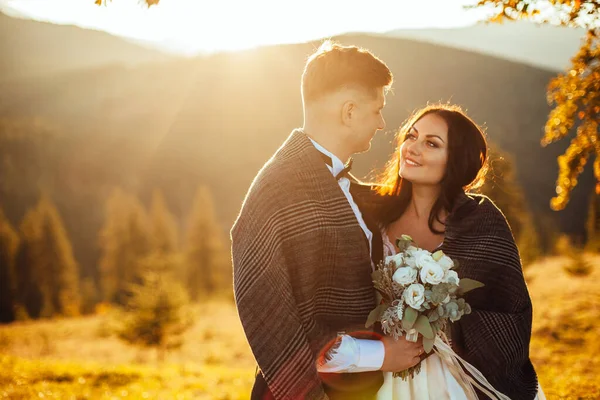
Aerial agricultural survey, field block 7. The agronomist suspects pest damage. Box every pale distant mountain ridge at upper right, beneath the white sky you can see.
[387,21,586,71]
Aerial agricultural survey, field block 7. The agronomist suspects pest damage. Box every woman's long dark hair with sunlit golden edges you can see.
[375,104,488,234]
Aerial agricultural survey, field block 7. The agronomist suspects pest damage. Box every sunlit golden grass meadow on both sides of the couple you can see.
[0,256,600,400]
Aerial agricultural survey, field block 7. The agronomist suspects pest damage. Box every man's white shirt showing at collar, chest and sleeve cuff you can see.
[309,138,385,372]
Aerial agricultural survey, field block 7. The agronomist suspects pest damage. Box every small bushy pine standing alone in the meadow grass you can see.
[118,253,192,361]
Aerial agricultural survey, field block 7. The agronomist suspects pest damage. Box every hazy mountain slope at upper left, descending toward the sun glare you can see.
[0,13,170,81]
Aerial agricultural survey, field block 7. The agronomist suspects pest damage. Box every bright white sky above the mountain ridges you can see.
[0,0,496,55]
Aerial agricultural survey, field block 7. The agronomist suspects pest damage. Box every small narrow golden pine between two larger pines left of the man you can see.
[150,190,178,254]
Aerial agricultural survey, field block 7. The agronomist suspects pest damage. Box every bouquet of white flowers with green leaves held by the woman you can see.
[366,235,484,380]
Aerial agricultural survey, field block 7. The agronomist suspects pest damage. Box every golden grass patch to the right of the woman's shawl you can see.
[525,255,600,400]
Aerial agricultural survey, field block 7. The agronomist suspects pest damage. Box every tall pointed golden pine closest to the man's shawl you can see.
[185,187,230,300]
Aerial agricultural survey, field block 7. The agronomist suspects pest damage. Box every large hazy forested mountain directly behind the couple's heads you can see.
[0,29,594,276]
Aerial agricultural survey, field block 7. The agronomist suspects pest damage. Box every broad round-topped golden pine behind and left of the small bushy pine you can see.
[99,189,151,304]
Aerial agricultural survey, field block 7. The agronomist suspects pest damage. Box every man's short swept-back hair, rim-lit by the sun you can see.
[302,40,393,102]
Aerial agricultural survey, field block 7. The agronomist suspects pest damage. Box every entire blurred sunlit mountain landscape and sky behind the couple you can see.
[0,0,600,399]
